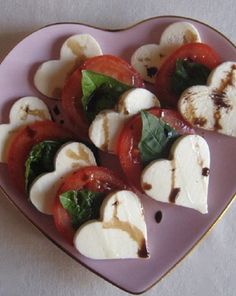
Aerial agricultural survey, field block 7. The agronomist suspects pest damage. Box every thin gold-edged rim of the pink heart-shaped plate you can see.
[0,15,236,295]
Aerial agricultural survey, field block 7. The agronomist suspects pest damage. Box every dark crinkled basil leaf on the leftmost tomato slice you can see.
[25,141,64,192]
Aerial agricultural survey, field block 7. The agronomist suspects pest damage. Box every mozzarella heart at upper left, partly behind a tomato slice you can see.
[34,34,102,99]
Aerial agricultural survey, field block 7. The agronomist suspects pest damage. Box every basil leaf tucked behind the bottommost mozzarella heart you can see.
[59,189,104,229]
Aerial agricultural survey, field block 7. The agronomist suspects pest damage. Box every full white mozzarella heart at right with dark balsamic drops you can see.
[141,135,210,214]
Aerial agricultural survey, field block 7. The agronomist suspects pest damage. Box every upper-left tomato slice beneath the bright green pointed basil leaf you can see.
[62,55,144,138]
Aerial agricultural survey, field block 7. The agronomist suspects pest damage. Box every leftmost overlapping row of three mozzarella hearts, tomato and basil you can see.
[0,97,149,259]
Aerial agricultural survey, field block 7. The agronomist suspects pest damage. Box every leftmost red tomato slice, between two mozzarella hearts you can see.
[7,120,75,192]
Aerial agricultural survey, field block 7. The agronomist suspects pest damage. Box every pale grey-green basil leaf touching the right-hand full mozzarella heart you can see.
[138,111,179,165]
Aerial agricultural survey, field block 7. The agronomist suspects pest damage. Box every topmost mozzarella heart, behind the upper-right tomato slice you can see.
[131,22,201,83]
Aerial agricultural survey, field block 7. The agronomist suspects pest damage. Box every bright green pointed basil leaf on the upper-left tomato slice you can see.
[82,70,132,121]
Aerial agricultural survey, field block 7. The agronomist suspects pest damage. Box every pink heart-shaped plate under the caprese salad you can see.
[0,16,236,293]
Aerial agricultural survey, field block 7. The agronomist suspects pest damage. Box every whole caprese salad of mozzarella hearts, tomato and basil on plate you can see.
[0,22,236,259]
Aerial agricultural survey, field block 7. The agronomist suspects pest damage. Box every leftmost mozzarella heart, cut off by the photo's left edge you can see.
[0,97,51,162]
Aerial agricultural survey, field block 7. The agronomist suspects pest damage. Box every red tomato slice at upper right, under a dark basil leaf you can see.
[156,43,221,107]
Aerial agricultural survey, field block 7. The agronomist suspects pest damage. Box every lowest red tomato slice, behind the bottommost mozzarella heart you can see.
[53,166,127,243]
